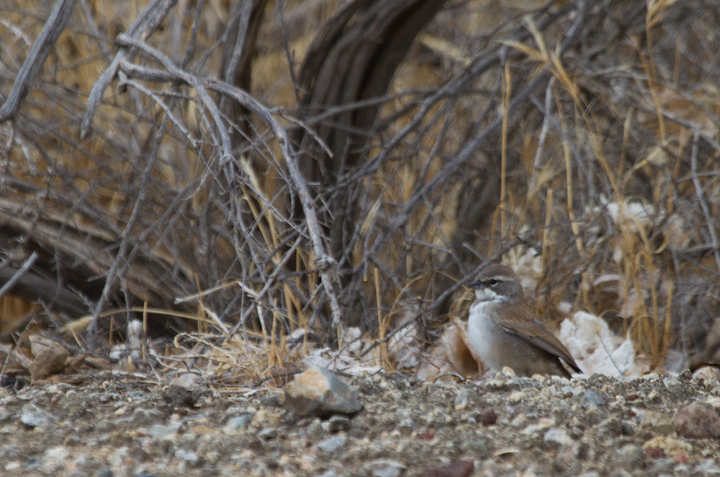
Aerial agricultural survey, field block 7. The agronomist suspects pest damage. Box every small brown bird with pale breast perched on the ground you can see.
[468,264,582,378]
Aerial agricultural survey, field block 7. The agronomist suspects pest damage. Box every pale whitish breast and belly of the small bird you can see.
[468,301,505,371]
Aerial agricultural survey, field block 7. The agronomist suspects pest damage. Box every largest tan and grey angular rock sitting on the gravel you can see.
[284,366,363,418]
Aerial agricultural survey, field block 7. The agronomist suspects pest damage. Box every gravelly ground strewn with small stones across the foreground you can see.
[0,372,720,477]
